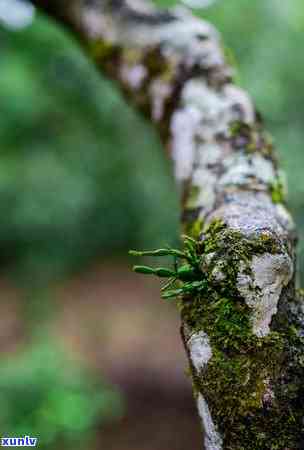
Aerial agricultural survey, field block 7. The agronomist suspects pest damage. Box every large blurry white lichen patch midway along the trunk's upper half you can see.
[170,78,254,185]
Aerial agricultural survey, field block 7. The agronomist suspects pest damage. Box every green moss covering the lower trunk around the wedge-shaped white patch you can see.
[180,222,304,450]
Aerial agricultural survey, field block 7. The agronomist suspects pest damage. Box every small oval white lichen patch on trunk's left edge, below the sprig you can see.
[187,331,212,372]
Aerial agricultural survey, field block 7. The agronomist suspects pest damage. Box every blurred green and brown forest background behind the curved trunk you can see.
[0,0,304,450]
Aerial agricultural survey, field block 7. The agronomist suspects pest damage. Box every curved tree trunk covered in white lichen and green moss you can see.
[29,0,304,450]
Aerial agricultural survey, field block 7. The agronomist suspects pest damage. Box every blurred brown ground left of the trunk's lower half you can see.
[0,261,201,450]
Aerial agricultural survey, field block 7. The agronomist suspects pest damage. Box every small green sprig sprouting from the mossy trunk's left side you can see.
[129,235,207,300]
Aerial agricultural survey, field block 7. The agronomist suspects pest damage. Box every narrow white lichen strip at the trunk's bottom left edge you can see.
[197,394,223,450]
